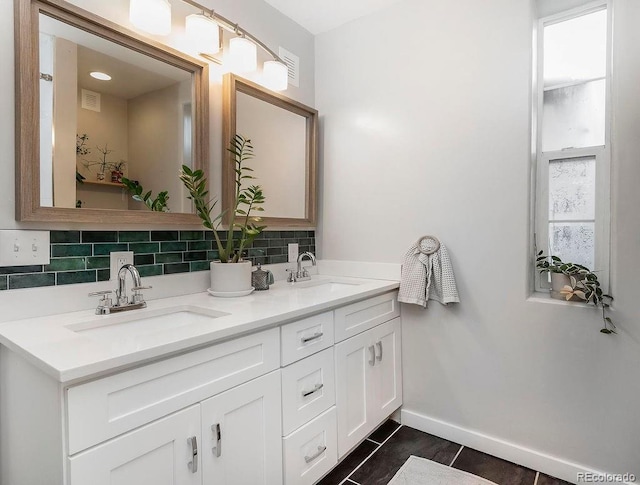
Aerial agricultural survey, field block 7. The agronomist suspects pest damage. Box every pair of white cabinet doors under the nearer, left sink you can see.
[69,371,282,485]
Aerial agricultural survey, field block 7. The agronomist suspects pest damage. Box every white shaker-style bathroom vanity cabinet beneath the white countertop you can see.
[0,289,402,485]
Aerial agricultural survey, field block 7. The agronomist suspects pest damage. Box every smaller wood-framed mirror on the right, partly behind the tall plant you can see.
[222,74,318,227]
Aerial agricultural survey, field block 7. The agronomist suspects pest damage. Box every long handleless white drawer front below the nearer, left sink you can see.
[67,328,280,454]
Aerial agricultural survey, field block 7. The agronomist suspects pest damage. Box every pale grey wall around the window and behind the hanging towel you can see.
[316,0,640,480]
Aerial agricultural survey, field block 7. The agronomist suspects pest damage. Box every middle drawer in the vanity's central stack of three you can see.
[282,348,336,435]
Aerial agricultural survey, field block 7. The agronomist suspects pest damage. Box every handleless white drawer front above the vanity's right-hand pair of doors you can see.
[335,291,400,342]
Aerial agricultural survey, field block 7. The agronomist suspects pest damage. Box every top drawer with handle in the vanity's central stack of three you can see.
[281,312,333,366]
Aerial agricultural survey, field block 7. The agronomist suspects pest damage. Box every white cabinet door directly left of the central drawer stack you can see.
[201,370,282,485]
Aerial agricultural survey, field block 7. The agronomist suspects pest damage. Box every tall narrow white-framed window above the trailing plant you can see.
[535,3,610,289]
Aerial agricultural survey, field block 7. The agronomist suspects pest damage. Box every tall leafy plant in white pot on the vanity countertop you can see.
[180,134,266,293]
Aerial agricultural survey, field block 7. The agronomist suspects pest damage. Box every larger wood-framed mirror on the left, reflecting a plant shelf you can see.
[14,0,209,225]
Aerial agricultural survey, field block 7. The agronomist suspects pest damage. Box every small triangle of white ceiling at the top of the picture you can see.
[266,0,401,35]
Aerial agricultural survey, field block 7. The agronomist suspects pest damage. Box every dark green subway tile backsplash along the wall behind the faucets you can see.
[0,230,316,290]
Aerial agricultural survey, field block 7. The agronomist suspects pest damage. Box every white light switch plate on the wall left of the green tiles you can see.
[0,230,51,266]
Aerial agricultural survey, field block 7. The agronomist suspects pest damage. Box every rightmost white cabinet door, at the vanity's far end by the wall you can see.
[370,318,402,425]
